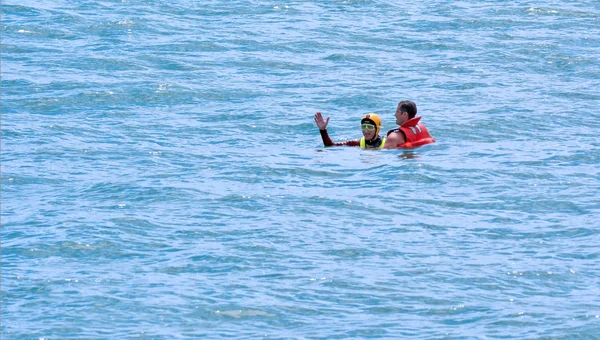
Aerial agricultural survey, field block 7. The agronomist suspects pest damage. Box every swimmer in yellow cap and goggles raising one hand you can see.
[315,112,386,149]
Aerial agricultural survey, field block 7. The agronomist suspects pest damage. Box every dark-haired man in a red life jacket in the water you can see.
[384,100,435,149]
